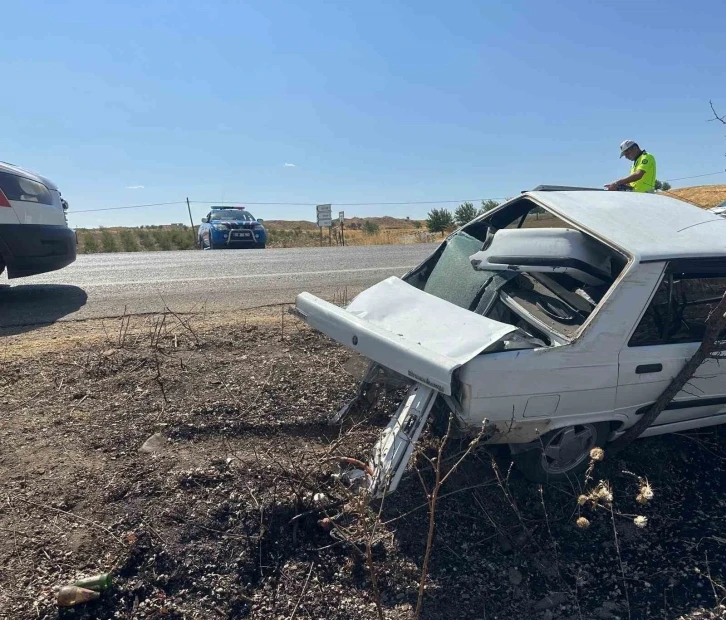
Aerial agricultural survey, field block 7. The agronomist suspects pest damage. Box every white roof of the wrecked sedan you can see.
[524,191,726,260]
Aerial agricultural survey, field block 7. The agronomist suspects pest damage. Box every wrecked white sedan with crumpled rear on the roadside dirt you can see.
[296,190,726,497]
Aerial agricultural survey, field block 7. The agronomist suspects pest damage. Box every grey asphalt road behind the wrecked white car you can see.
[0,244,436,328]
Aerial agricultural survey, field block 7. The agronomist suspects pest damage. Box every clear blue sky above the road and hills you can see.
[0,0,726,226]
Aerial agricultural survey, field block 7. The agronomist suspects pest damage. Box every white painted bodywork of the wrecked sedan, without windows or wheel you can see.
[297,191,726,492]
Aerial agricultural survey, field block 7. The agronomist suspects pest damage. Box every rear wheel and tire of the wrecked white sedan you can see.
[513,422,610,482]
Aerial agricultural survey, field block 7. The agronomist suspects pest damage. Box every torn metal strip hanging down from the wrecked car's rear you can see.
[371,383,438,497]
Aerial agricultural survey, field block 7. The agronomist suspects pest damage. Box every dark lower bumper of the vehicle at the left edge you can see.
[0,224,76,279]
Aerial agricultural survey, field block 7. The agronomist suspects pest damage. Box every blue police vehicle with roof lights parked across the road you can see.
[199,207,267,250]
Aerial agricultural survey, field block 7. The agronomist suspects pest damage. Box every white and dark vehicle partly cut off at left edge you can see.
[0,162,76,278]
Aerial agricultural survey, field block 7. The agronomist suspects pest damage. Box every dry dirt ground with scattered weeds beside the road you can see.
[0,309,726,620]
